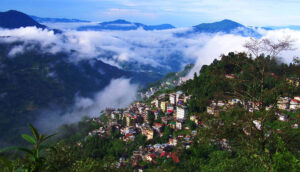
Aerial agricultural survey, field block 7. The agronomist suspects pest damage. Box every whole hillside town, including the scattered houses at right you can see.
[85,85,300,167]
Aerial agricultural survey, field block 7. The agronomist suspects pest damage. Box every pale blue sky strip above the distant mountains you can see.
[0,0,300,27]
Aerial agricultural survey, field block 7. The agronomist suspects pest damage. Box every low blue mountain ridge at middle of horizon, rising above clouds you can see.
[77,19,175,31]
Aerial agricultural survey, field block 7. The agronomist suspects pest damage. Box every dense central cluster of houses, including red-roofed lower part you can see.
[84,91,201,165]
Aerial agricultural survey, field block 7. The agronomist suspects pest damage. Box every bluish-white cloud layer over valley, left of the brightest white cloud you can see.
[0,27,194,67]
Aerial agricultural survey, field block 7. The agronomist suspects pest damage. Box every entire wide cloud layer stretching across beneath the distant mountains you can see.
[0,27,300,72]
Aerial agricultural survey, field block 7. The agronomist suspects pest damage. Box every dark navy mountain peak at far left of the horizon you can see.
[0,10,47,29]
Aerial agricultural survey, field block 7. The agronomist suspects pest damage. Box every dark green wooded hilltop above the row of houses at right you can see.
[184,53,300,112]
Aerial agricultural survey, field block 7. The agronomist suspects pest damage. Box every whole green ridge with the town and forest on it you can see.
[3,53,300,171]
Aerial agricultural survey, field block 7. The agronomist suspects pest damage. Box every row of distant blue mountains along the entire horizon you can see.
[0,10,300,33]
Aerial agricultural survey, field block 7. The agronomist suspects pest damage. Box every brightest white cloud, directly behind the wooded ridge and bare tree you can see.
[187,28,300,78]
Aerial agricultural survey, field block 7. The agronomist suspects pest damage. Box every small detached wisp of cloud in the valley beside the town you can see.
[35,78,138,133]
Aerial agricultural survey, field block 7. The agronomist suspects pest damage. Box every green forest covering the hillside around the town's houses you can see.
[0,53,300,172]
